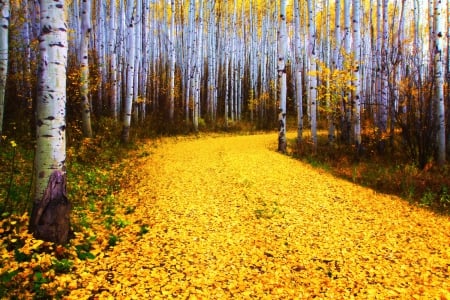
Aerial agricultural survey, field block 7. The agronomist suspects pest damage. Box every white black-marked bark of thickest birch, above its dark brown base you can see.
[34,0,67,201]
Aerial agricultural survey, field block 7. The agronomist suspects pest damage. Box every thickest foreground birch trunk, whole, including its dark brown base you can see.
[30,0,70,243]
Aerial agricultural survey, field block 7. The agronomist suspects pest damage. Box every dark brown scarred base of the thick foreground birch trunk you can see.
[30,170,71,244]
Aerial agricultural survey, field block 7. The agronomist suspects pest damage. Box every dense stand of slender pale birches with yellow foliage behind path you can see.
[0,0,450,166]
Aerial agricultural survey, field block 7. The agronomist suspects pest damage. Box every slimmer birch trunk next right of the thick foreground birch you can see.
[80,0,92,138]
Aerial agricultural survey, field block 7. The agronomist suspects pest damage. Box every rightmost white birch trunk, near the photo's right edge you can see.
[434,0,448,167]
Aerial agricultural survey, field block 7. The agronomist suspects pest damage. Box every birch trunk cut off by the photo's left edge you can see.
[0,0,9,138]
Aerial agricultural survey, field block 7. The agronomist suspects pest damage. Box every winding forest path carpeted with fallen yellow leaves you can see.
[2,134,450,299]
